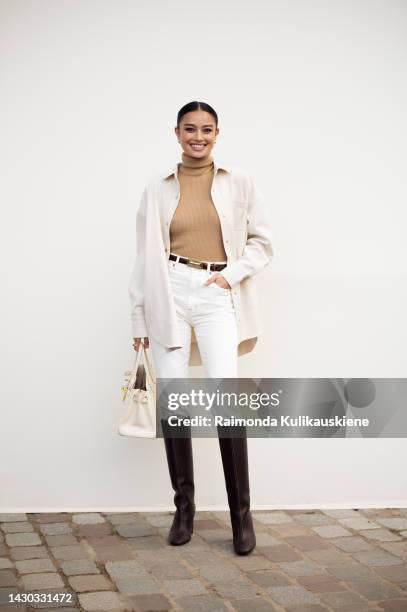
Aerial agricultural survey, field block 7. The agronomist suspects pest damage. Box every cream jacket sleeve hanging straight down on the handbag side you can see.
[128,187,148,338]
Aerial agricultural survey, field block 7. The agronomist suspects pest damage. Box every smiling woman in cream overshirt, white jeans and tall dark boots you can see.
[129,102,273,555]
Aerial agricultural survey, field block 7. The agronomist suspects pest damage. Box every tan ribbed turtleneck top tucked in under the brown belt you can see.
[170,153,227,261]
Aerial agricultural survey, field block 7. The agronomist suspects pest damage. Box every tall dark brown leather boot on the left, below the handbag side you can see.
[162,421,195,546]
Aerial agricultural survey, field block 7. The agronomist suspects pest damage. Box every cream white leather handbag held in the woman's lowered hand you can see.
[118,343,157,438]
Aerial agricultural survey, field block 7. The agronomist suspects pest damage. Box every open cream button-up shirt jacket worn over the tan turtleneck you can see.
[128,161,273,365]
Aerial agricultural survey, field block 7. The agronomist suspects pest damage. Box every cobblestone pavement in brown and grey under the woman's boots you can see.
[0,508,407,612]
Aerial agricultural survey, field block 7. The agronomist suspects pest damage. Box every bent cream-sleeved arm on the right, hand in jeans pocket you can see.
[220,176,274,287]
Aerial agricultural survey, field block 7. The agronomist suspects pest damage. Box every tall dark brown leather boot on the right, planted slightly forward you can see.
[218,427,256,555]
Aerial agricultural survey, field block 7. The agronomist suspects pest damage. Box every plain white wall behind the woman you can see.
[0,0,407,512]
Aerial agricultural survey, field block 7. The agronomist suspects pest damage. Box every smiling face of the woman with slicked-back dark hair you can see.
[175,110,219,158]
